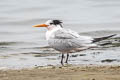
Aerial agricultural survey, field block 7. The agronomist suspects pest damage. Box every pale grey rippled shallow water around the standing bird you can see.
[0,0,120,68]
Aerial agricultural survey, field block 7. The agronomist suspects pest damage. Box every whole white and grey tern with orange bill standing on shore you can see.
[33,20,116,65]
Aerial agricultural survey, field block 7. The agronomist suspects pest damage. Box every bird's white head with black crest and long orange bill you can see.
[33,20,62,30]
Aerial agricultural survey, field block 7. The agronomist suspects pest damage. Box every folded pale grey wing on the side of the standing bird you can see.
[48,29,96,51]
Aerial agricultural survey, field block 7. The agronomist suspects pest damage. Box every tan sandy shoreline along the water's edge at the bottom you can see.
[0,65,120,80]
